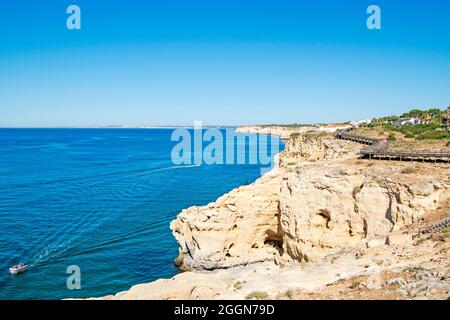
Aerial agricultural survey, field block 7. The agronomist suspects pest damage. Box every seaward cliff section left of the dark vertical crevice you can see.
[170,169,281,270]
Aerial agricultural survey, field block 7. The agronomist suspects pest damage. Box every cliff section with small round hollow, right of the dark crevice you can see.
[280,161,450,261]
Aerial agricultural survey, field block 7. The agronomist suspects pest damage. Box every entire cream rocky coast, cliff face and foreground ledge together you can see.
[89,127,450,299]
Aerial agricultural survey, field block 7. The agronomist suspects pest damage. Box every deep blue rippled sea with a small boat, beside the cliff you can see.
[0,129,282,299]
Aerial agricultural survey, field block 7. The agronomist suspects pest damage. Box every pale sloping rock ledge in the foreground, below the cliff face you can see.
[95,232,450,300]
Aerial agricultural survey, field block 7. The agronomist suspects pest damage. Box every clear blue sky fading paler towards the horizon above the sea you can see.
[0,0,450,126]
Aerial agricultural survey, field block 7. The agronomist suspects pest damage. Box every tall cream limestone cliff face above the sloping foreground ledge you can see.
[171,129,450,270]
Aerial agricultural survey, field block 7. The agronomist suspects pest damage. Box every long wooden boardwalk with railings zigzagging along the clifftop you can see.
[336,127,450,163]
